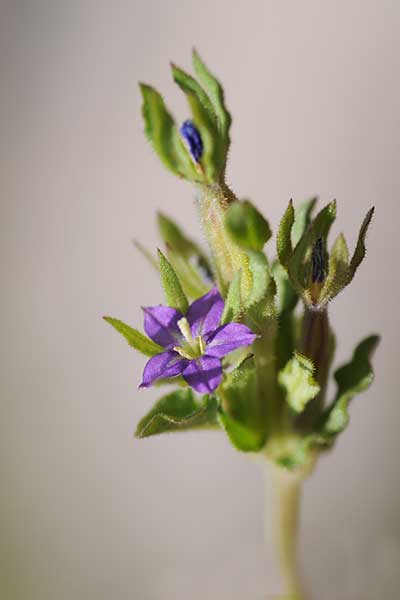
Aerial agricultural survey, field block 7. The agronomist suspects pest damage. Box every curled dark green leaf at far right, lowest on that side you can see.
[322,335,379,435]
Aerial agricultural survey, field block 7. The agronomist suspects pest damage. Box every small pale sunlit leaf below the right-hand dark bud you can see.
[278,351,320,413]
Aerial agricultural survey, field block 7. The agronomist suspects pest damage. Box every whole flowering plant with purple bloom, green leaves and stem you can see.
[105,51,378,599]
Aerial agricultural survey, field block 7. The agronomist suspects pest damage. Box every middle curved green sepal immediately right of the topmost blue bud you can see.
[171,64,220,183]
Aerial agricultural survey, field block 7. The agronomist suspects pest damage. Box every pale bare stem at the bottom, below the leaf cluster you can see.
[266,466,307,600]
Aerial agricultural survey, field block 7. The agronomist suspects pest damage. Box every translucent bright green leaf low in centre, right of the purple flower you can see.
[217,355,266,452]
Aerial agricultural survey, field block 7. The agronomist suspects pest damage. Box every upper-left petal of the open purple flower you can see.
[143,304,183,348]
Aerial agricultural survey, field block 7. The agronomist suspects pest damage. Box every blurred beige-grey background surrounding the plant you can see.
[0,0,400,600]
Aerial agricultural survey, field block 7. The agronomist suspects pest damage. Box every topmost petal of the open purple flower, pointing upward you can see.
[186,287,224,337]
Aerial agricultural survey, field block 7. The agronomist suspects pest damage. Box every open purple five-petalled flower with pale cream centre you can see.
[140,288,257,394]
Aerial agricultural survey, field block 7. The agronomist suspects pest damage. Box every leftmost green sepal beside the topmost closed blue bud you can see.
[140,83,197,179]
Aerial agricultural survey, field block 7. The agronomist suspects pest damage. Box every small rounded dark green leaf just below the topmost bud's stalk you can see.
[225,200,272,252]
